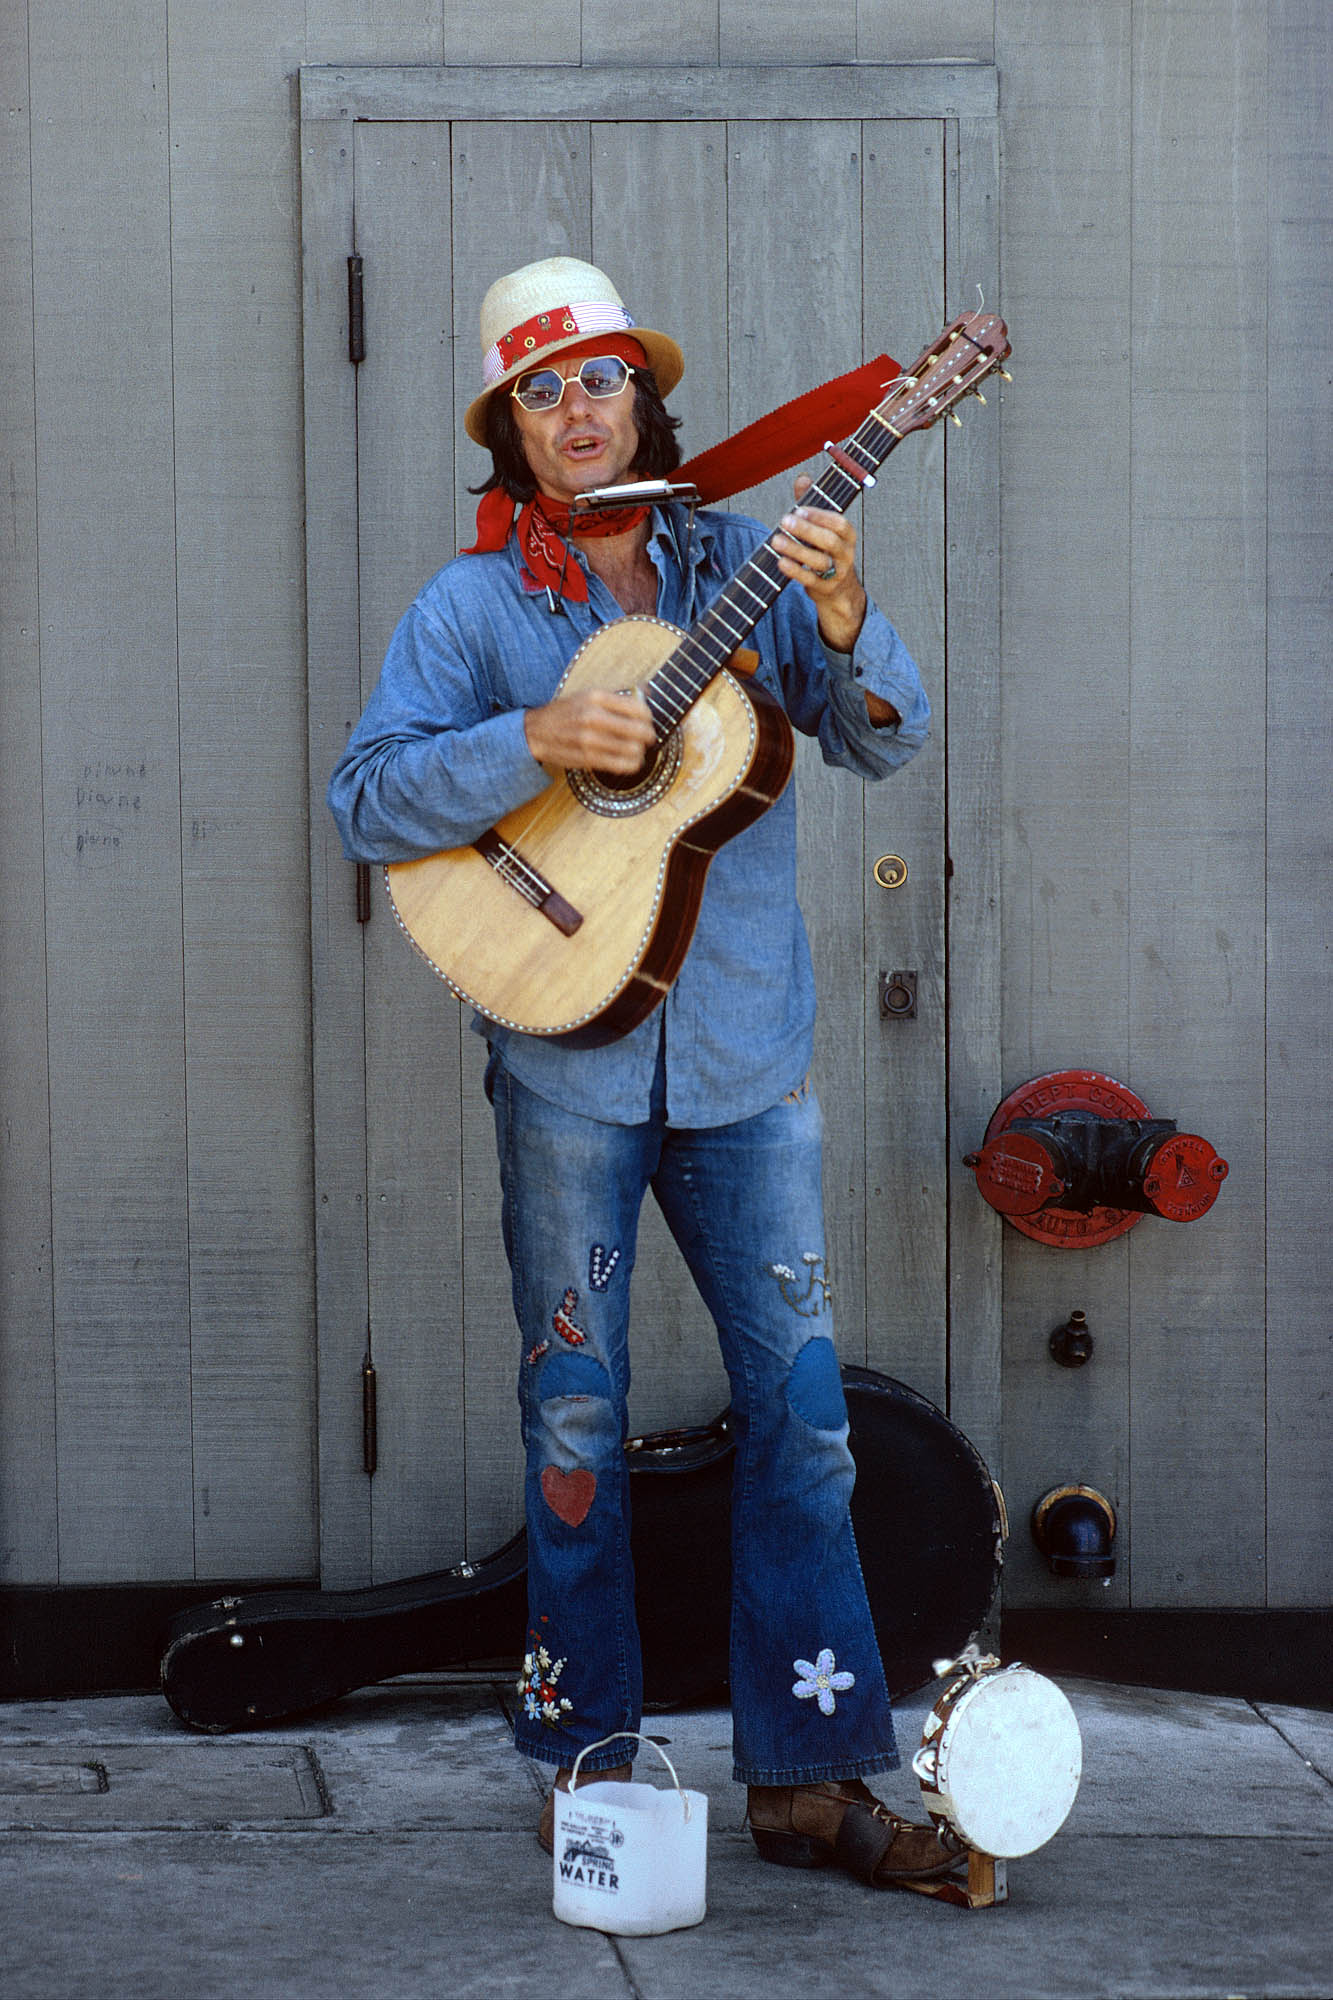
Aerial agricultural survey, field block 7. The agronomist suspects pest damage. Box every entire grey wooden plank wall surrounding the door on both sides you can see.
[0,0,1333,1606]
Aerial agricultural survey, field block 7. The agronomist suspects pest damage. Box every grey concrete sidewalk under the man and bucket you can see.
[0,1678,1333,2000]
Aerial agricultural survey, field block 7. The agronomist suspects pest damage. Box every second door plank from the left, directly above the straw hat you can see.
[452,120,592,1556]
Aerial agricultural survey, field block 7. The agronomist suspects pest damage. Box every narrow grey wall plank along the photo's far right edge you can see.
[1267,0,1333,1604]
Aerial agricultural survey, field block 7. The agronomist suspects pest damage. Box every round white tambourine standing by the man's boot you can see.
[913,1648,1083,1858]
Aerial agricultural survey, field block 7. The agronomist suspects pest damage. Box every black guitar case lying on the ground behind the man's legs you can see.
[162,1368,1003,1734]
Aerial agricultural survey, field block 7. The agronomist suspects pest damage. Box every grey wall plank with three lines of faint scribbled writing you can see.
[30,0,194,1582]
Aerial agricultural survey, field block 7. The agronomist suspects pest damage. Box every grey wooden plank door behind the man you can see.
[306,72,987,1580]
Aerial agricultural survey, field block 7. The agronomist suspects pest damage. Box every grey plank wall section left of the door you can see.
[0,0,316,1582]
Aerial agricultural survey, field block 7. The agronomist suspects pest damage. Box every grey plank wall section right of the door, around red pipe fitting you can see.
[997,0,1333,1608]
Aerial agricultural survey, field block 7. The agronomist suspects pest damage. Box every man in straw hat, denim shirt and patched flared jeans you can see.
[328,258,953,1882]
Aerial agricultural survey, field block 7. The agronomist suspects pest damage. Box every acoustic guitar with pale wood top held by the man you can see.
[384,312,1011,1046]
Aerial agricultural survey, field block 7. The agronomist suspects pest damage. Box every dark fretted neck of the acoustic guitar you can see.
[642,410,901,740]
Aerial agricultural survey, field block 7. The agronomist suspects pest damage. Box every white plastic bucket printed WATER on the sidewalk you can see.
[552,1730,709,1938]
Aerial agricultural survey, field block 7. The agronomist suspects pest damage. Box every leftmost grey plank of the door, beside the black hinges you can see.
[354,124,464,1582]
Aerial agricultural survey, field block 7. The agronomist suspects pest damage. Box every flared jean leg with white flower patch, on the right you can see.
[652,1090,899,1784]
